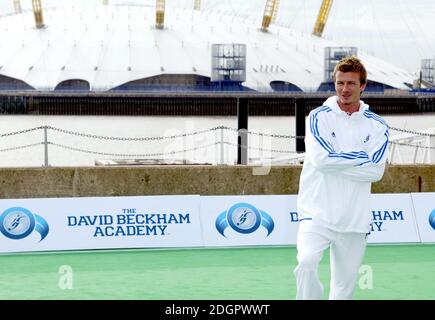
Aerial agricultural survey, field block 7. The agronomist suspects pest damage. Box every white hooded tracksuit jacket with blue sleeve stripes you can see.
[297,96,388,233]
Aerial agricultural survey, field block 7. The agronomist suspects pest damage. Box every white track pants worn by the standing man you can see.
[294,220,366,300]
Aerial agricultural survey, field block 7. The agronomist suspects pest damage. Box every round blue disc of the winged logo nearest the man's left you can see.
[227,203,261,233]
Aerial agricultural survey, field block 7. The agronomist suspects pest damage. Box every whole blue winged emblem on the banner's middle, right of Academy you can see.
[216,202,275,237]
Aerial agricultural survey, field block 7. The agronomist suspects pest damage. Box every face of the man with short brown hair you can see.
[335,71,366,105]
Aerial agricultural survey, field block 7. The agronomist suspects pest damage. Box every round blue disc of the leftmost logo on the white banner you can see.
[0,207,35,239]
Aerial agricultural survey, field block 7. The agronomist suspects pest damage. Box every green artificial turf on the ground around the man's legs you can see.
[0,245,435,300]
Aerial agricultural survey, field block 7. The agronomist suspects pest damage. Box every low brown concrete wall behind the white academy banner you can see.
[0,165,435,199]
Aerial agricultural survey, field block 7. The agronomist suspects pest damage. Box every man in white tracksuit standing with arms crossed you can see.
[294,57,388,299]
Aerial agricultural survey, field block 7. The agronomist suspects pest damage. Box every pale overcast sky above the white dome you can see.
[0,0,435,73]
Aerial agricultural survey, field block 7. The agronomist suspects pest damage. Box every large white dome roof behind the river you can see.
[0,1,413,91]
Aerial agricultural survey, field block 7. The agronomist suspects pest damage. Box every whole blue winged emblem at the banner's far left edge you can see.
[0,207,49,242]
